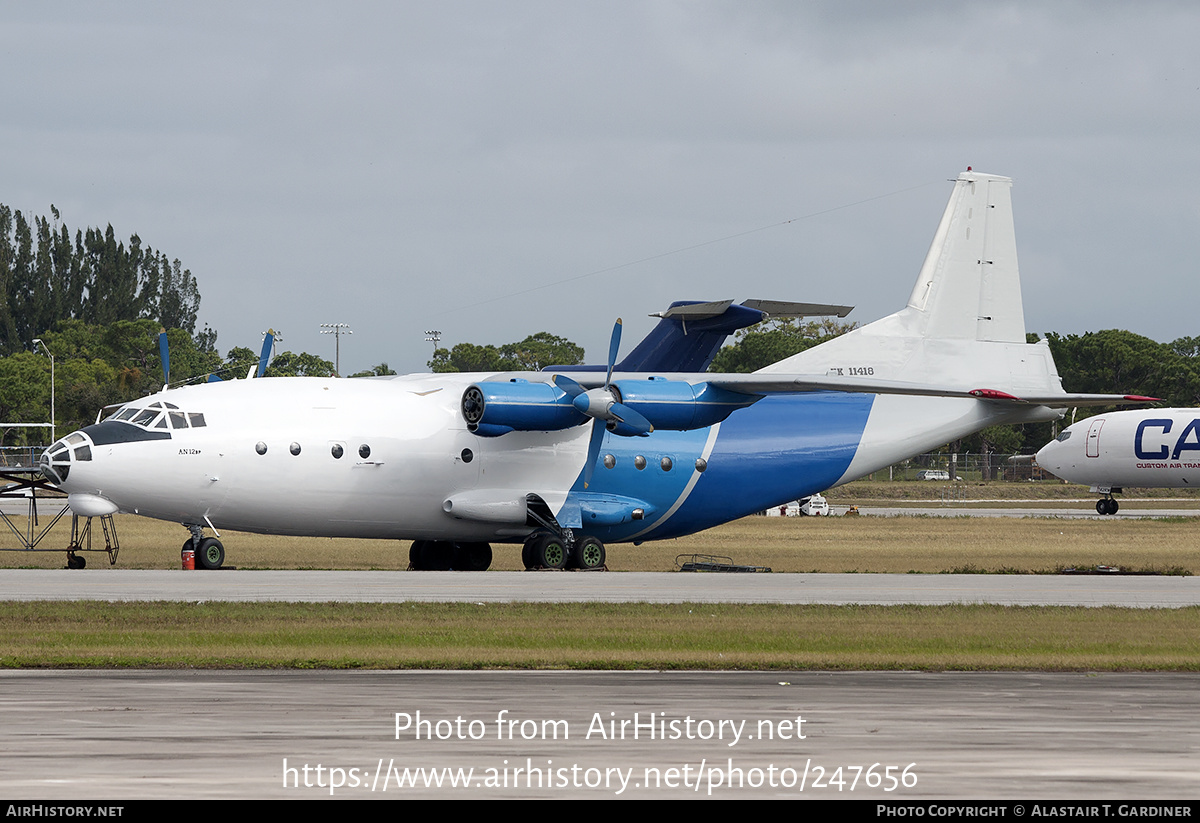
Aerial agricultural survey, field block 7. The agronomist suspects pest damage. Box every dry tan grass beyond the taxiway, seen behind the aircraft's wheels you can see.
[0,508,1200,573]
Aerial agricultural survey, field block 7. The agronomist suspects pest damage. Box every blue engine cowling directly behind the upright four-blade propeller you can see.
[613,377,762,432]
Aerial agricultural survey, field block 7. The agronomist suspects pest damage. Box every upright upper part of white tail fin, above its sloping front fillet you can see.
[908,172,1025,343]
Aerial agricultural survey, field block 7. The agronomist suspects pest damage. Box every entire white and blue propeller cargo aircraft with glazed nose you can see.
[41,169,1140,570]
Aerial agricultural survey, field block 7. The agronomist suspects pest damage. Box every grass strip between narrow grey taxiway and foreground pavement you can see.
[0,602,1200,671]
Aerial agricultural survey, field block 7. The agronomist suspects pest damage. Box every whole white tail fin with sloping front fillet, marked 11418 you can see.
[762,170,1062,395]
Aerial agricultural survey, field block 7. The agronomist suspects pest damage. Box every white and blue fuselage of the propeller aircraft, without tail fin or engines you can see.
[43,374,1045,542]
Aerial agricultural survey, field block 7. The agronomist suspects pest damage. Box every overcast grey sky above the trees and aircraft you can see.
[0,0,1200,373]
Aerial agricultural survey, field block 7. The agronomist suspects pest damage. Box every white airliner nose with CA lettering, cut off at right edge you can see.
[1037,409,1200,515]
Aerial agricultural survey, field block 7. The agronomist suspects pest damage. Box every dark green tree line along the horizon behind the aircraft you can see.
[0,204,1200,460]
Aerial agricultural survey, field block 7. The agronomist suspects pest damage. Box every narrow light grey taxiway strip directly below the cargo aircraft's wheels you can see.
[0,569,1200,608]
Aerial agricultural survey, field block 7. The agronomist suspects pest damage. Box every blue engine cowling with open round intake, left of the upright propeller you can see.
[462,380,588,437]
